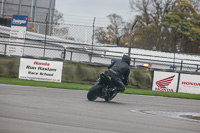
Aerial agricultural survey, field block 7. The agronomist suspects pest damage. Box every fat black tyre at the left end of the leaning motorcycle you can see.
[87,82,102,101]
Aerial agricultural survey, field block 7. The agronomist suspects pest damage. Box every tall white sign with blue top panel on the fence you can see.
[6,15,28,56]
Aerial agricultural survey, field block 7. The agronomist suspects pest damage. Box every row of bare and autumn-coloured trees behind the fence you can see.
[95,0,200,54]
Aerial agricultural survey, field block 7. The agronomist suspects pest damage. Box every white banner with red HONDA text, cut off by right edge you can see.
[178,74,200,94]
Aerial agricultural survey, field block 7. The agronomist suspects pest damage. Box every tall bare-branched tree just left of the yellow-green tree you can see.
[130,0,175,51]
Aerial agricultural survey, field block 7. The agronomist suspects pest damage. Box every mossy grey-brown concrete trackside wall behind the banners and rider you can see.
[0,56,152,89]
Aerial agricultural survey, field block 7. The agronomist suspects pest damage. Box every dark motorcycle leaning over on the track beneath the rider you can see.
[87,72,118,102]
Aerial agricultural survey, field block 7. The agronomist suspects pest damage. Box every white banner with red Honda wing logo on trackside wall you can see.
[152,71,178,92]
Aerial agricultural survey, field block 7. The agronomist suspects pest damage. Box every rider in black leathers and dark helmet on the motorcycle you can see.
[108,55,131,92]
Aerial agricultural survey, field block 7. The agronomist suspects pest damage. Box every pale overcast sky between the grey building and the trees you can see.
[56,0,138,26]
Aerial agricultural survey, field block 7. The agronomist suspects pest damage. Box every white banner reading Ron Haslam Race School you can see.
[19,58,63,82]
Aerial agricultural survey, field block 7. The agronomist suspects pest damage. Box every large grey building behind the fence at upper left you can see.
[0,0,56,35]
